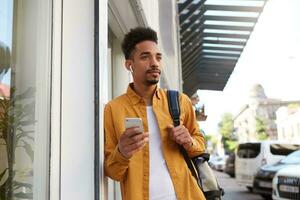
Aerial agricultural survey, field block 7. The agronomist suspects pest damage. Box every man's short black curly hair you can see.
[122,27,157,59]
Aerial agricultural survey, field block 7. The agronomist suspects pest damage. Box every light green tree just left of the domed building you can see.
[218,113,237,153]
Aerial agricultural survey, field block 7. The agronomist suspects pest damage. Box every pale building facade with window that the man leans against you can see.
[0,0,182,200]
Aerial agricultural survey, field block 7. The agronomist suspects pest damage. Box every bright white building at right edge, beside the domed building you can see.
[276,105,300,142]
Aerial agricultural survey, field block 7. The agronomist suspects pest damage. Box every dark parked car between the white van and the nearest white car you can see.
[253,150,300,199]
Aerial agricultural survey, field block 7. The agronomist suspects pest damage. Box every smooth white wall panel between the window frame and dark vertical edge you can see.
[60,0,94,200]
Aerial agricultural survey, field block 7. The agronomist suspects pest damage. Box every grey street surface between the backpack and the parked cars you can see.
[214,171,263,200]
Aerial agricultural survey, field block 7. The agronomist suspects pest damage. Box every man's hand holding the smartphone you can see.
[118,127,149,159]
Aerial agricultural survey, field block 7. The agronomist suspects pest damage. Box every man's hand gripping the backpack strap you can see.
[167,125,193,150]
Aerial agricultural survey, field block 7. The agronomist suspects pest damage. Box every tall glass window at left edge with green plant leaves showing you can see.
[0,0,51,200]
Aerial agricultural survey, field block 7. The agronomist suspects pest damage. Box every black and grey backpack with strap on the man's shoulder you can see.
[167,90,224,200]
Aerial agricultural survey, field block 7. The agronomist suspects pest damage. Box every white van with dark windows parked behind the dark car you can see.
[235,141,300,191]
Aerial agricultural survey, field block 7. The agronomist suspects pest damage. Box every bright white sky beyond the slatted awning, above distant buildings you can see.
[198,0,300,134]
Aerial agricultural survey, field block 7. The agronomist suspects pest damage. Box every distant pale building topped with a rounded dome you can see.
[233,84,300,142]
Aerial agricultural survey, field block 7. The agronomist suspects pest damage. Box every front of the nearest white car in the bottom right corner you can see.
[272,165,300,200]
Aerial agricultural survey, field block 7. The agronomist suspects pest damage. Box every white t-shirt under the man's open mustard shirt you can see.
[147,106,177,200]
